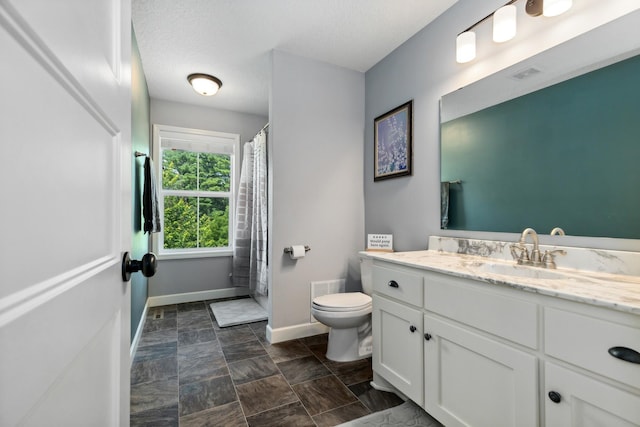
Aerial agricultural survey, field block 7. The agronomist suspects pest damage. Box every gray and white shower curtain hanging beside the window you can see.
[233,127,268,296]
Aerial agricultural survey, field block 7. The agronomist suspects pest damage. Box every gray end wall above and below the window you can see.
[149,99,268,297]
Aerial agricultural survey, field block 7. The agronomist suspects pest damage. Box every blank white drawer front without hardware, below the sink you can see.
[424,273,538,349]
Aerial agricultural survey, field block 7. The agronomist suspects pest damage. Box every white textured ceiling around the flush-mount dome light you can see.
[132,0,457,116]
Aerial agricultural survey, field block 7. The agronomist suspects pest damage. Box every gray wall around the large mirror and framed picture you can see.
[364,0,640,250]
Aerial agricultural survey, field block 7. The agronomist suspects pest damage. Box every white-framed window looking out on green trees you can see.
[153,125,240,258]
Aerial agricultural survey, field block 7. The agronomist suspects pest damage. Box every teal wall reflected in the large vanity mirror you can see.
[441,56,640,239]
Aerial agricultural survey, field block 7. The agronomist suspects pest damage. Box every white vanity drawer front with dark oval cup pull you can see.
[544,307,640,388]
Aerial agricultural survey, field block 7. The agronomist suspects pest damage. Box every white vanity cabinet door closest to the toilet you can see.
[372,295,423,405]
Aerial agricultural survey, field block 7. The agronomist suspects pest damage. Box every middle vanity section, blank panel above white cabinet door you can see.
[424,272,539,427]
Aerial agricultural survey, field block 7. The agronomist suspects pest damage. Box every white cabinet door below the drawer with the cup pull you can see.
[543,363,640,427]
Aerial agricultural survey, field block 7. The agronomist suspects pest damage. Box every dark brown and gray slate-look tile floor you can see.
[131,301,402,427]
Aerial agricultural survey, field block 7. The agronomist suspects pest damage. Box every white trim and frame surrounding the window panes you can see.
[151,124,241,259]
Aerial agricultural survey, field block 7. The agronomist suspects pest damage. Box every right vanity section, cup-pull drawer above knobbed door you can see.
[543,305,640,427]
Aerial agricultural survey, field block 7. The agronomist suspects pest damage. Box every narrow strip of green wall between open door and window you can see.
[131,28,151,341]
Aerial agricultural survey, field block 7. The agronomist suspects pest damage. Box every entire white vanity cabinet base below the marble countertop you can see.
[373,259,640,427]
